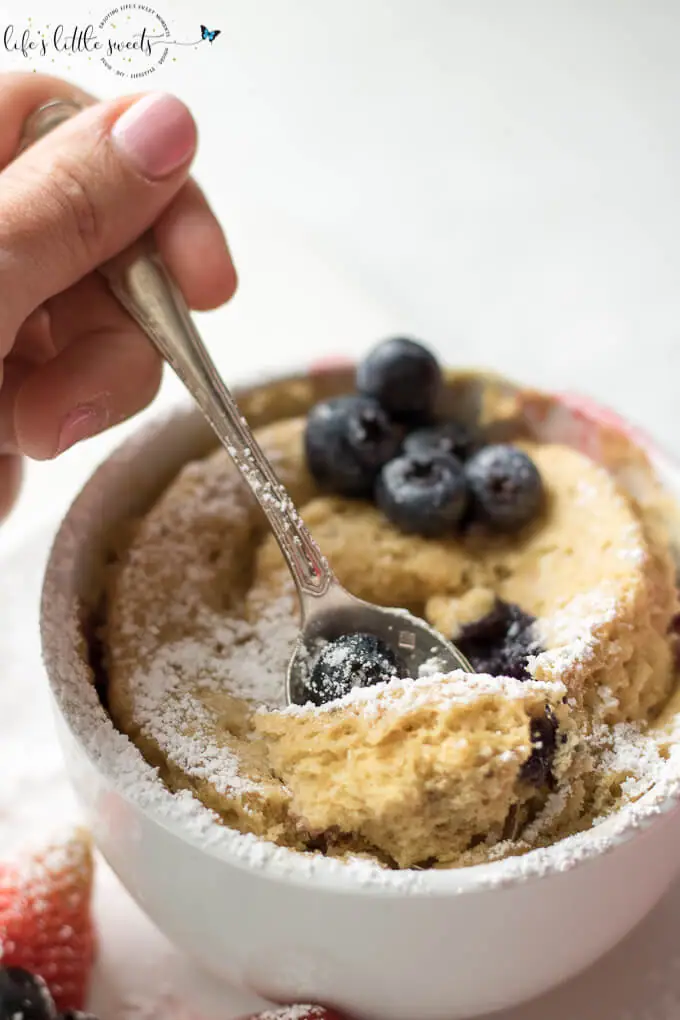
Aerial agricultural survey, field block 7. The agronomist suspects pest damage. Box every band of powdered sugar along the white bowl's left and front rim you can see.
[38,391,680,894]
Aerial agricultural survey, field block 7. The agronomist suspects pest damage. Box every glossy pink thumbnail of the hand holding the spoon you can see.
[111,93,196,181]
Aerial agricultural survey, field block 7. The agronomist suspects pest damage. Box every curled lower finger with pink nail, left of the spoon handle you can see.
[14,275,161,460]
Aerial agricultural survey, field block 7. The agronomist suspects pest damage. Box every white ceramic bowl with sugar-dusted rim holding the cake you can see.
[42,371,680,1020]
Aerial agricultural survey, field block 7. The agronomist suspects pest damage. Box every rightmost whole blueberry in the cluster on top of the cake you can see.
[465,444,543,531]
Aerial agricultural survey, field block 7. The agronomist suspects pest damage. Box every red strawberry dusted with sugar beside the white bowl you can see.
[0,831,95,1012]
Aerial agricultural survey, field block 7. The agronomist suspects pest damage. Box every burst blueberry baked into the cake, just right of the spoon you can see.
[455,599,540,680]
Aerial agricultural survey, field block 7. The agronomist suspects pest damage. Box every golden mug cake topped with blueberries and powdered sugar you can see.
[98,338,678,870]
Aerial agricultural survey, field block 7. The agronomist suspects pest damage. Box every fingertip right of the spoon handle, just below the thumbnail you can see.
[154,180,237,311]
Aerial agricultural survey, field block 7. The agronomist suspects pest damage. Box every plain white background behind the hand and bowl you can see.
[0,0,680,543]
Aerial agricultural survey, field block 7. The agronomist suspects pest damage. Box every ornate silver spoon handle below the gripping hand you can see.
[99,238,333,600]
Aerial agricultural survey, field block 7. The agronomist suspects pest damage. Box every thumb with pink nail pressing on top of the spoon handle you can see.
[0,93,197,357]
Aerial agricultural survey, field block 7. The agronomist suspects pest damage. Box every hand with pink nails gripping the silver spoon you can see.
[0,74,237,518]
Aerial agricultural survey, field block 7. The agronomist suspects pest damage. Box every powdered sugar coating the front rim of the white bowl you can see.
[48,575,680,894]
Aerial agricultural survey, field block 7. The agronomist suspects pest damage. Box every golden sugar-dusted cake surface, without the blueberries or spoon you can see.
[104,375,676,867]
